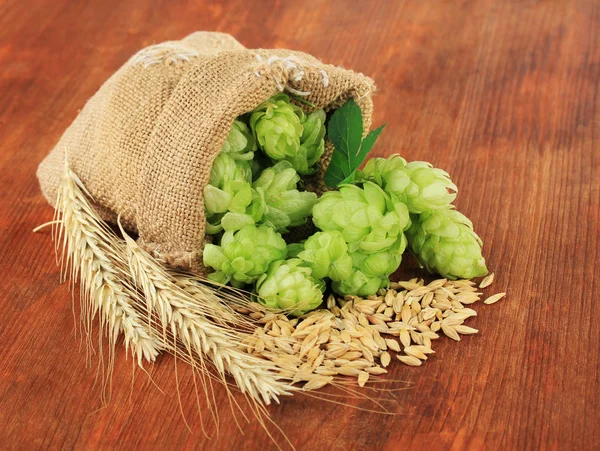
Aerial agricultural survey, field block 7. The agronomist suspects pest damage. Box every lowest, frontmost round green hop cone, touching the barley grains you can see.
[256,258,324,316]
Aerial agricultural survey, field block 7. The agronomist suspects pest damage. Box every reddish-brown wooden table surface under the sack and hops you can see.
[0,0,600,450]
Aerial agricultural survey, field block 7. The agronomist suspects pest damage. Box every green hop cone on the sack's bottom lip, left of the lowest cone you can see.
[203,224,287,287]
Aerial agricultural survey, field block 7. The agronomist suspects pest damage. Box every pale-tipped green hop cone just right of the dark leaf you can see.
[359,155,457,213]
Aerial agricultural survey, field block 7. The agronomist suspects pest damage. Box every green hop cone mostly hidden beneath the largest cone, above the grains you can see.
[332,234,406,296]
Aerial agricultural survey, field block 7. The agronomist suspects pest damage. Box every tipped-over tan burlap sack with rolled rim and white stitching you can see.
[37,32,374,273]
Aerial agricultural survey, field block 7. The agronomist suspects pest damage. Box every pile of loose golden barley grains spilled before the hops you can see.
[233,274,505,390]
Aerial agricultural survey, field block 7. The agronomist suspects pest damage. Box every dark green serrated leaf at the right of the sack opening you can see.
[323,99,385,188]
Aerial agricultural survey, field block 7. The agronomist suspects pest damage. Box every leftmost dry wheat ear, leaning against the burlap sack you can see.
[54,161,162,366]
